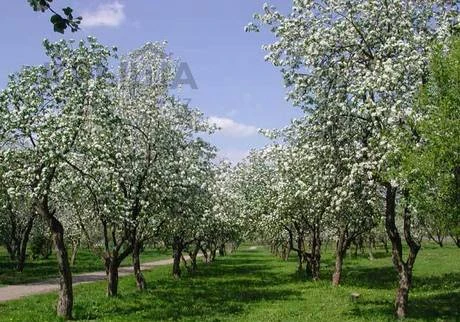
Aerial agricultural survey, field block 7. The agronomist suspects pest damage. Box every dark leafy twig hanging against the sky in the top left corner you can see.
[28,0,82,33]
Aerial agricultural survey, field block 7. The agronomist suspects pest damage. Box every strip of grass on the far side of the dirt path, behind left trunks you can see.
[0,247,171,286]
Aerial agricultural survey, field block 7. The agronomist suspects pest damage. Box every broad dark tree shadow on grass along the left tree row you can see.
[76,252,301,321]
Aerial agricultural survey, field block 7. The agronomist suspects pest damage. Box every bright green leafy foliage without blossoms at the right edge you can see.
[403,38,460,240]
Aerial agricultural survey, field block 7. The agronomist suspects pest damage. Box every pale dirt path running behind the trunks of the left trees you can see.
[0,256,196,302]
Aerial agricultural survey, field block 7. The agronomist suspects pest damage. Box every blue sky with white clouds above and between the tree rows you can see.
[0,0,300,161]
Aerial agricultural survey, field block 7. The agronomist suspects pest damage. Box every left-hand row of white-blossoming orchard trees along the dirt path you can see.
[0,38,243,319]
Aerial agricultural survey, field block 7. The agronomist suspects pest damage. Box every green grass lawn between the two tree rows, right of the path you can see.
[0,245,460,322]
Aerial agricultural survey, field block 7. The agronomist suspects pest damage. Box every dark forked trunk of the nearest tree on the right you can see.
[385,183,420,318]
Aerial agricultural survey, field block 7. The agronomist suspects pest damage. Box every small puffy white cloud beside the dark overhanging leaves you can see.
[81,1,125,27]
